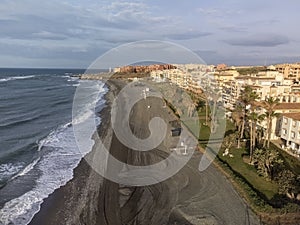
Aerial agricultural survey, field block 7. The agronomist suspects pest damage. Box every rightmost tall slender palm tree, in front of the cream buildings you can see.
[262,97,279,148]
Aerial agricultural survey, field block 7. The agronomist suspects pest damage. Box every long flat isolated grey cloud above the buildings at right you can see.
[224,34,289,47]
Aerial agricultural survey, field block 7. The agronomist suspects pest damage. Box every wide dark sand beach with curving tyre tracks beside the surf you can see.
[30,81,259,225]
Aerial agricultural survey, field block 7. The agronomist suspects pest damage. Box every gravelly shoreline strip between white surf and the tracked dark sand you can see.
[29,79,120,225]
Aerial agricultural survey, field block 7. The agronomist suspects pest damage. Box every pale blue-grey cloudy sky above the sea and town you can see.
[0,0,300,68]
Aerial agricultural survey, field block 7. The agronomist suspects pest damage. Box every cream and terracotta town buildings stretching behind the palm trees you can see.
[151,63,300,156]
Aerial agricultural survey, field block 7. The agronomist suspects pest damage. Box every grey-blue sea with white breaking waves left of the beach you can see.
[0,69,107,225]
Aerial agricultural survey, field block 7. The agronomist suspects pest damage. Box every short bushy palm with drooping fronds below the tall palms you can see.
[253,149,283,180]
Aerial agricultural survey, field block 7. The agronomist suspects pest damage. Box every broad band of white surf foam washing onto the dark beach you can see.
[0,81,106,225]
